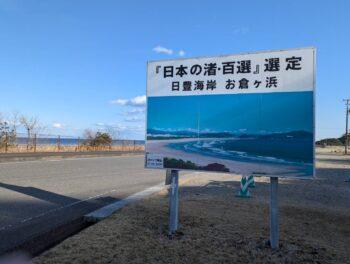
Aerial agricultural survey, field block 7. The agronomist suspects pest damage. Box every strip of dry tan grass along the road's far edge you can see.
[0,145,144,153]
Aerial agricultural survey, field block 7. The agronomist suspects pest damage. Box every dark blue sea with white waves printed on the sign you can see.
[168,138,314,164]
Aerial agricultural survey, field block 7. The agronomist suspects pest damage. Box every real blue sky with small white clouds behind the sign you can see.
[0,0,350,138]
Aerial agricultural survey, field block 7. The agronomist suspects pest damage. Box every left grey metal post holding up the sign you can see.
[169,170,179,238]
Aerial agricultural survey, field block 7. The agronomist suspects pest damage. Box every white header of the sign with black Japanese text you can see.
[148,49,313,96]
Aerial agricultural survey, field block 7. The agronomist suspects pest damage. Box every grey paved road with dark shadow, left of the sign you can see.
[0,155,164,253]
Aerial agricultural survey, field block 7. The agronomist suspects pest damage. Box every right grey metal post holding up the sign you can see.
[270,177,279,249]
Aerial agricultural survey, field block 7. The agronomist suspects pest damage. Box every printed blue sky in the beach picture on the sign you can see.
[147,92,313,134]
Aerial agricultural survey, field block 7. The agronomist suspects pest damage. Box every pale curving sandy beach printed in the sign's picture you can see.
[146,138,311,177]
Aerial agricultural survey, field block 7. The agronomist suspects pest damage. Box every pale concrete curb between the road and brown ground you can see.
[84,182,167,223]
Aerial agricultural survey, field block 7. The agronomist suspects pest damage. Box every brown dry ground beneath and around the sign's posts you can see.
[33,154,350,264]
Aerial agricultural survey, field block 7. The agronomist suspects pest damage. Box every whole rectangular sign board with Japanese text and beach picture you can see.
[145,48,315,178]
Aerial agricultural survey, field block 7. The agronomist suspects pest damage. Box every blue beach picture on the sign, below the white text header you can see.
[146,90,314,178]
